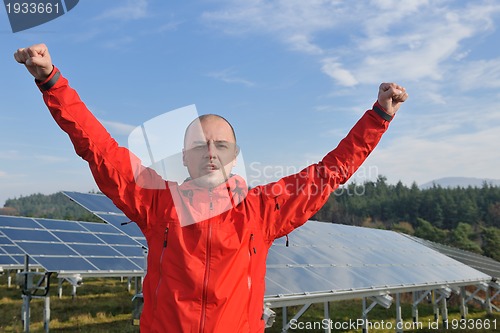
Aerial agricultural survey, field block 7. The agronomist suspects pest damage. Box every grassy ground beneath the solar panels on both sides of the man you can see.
[0,275,500,333]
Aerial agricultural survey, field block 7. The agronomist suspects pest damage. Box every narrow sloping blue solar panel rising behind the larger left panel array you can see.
[63,191,147,246]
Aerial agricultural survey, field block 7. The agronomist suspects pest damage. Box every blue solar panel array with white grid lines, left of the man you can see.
[0,216,144,276]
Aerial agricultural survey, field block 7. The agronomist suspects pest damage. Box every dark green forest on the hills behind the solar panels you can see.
[0,176,500,261]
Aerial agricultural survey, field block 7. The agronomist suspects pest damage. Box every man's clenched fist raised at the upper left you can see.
[14,44,53,81]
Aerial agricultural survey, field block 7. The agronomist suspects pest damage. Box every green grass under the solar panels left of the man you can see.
[0,275,139,333]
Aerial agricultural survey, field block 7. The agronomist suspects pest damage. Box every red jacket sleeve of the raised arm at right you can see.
[252,103,392,242]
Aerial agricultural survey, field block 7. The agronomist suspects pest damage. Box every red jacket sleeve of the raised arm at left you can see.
[37,67,171,231]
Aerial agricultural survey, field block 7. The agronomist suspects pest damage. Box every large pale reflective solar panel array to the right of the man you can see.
[266,221,491,300]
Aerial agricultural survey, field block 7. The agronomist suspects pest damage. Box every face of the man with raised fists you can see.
[183,116,238,188]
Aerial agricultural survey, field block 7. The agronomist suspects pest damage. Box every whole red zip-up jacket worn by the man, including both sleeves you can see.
[38,68,390,333]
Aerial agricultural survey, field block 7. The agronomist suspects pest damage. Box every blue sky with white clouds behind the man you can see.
[0,0,500,206]
